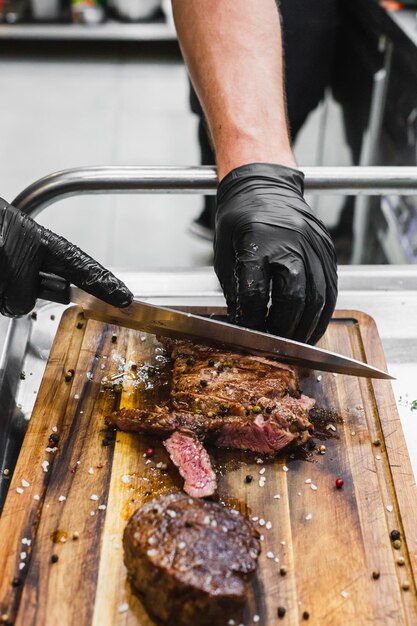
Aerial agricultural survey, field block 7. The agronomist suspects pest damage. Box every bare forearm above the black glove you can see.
[172,0,295,180]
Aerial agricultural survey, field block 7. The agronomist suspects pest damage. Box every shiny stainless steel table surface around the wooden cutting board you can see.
[0,266,417,507]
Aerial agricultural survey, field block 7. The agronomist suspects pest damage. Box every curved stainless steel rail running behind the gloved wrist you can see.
[13,166,417,216]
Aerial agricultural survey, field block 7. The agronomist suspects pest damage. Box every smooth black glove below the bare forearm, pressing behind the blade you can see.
[214,163,337,343]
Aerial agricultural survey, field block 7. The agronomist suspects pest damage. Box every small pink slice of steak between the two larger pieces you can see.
[164,432,217,498]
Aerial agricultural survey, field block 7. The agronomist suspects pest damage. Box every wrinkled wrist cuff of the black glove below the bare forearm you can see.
[217,163,304,202]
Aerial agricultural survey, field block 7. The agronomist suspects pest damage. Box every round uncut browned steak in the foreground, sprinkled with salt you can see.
[123,493,260,626]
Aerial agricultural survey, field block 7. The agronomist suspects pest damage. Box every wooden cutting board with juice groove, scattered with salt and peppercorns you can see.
[0,308,417,626]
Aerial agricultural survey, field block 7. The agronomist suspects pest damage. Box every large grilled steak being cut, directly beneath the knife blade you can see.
[108,340,315,454]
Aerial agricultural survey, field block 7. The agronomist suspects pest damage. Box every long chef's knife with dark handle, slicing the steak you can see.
[39,274,393,379]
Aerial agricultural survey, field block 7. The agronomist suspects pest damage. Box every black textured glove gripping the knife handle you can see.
[0,198,133,317]
